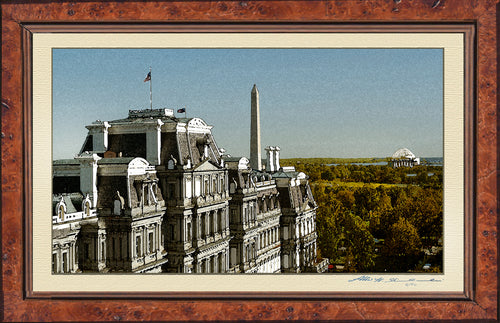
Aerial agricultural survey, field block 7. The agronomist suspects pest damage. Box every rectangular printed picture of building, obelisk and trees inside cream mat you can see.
[52,48,443,275]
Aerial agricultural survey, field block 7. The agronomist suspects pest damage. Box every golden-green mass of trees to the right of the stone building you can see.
[282,161,443,272]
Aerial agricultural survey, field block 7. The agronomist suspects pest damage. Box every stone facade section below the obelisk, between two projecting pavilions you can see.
[226,157,281,273]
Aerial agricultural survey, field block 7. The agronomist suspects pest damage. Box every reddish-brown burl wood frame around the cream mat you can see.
[0,0,499,321]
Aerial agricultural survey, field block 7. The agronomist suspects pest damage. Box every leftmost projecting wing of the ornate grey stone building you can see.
[52,153,167,272]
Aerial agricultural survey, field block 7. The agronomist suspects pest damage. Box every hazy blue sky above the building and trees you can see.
[53,49,443,159]
